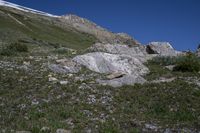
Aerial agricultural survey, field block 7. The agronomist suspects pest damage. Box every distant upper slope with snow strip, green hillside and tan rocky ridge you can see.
[0,0,138,52]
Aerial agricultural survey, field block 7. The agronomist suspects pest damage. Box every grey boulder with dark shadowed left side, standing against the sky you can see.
[146,42,181,56]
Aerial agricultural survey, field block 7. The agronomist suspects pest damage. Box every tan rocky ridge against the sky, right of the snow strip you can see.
[60,15,138,45]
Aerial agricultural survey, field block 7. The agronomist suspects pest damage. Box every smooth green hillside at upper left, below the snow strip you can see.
[0,7,95,50]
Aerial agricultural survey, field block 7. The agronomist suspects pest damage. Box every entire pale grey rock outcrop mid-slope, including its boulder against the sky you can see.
[49,42,181,87]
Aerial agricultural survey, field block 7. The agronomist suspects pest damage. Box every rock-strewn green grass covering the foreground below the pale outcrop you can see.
[0,54,200,133]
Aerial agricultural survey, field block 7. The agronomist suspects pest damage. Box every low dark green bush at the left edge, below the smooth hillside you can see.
[0,43,28,56]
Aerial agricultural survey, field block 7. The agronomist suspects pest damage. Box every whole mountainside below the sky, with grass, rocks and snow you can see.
[0,0,200,133]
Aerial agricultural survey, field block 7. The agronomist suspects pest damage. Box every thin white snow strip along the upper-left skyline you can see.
[0,0,59,17]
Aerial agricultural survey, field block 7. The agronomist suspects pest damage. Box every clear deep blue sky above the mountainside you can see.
[4,0,200,50]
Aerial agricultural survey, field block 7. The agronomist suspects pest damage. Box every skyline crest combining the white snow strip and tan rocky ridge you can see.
[0,0,139,45]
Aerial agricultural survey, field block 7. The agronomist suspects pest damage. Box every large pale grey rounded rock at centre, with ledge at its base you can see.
[73,52,149,87]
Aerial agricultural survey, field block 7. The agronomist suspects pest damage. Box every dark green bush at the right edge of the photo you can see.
[173,54,200,72]
